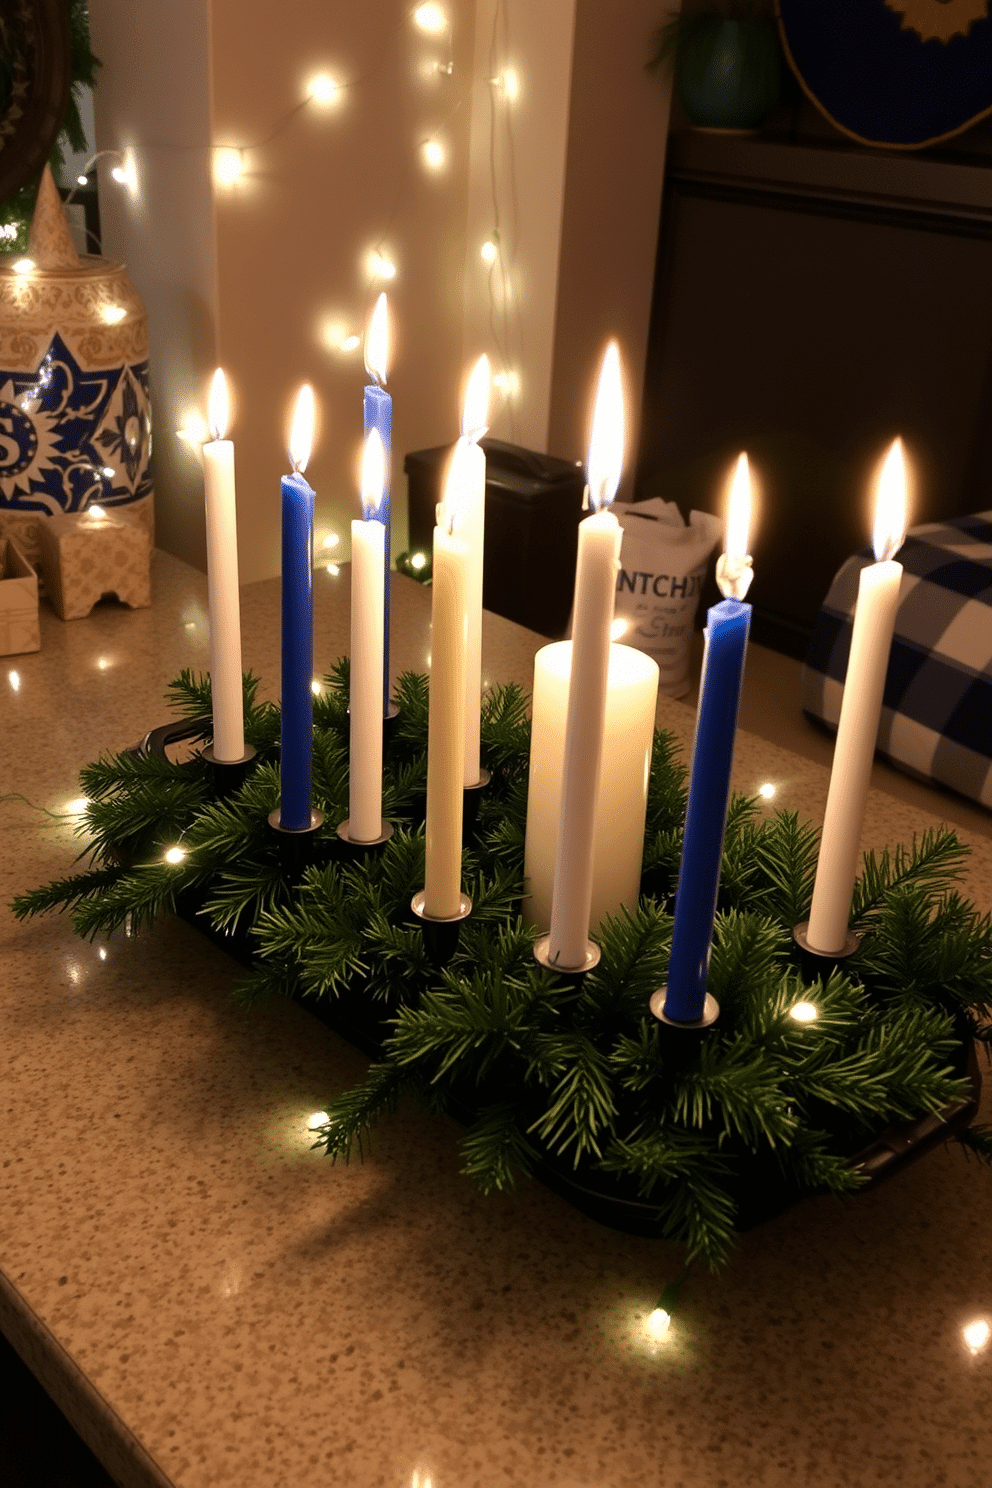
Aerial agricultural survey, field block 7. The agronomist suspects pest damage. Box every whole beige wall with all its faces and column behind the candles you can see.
[92,0,668,582]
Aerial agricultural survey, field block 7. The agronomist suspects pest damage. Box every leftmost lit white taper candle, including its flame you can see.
[204,368,244,760]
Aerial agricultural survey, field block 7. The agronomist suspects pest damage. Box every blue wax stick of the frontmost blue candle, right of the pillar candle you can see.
[665,600,751,1022]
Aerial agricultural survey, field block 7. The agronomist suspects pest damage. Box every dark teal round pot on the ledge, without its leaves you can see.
[675,16,782,129]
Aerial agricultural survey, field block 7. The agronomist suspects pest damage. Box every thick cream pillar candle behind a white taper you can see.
[524,641,659,930]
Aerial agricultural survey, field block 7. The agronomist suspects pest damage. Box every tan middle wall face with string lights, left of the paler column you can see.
[211,0,473,576]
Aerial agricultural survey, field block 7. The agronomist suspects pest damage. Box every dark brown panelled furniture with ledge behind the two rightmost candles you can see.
[638,93,992,656]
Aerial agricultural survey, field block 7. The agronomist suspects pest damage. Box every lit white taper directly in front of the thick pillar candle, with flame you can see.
[547,341,623,970]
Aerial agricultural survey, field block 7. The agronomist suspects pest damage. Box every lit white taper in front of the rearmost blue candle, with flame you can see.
[348,429,385,842]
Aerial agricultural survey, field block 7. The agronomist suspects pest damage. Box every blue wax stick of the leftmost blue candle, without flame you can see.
[280,472,314,832]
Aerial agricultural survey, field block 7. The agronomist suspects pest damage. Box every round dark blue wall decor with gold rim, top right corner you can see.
[776,0,992,150]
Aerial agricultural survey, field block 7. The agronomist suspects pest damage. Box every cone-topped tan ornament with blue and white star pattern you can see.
[0,165,153,577]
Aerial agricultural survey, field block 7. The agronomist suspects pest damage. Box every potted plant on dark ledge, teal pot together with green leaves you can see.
[647,0,782,131]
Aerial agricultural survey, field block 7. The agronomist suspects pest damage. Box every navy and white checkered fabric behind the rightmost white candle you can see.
[803,512,992,808]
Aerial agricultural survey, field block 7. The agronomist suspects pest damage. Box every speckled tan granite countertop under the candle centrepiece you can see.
[0,555,992,1488]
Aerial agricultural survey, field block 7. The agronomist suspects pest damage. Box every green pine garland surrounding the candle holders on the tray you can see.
[13,661,992,1266]
